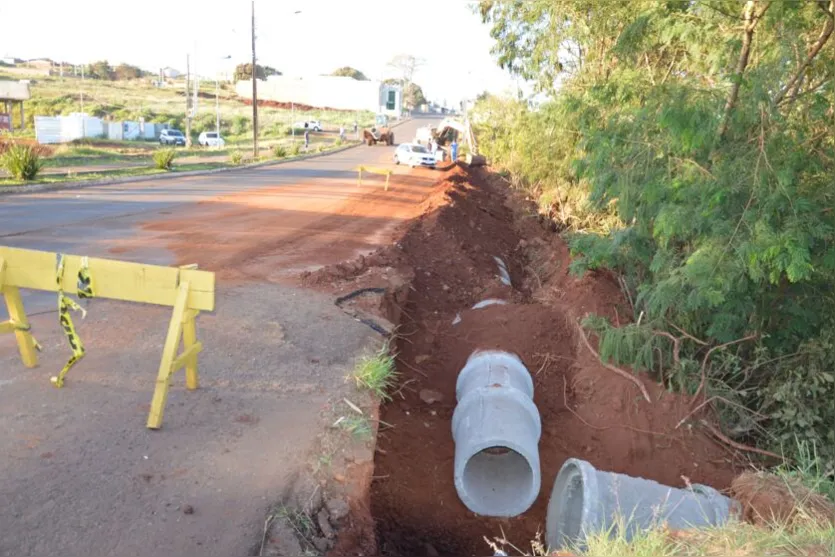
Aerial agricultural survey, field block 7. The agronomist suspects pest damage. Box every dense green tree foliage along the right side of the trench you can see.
[473,0,835,460]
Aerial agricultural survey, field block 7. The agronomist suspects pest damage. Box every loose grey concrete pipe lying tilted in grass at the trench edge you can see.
[545,458,736,550]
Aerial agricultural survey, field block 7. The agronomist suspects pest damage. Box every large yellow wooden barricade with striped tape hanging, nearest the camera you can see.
[0,246,215,429]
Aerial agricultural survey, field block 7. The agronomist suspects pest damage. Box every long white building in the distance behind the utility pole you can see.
[235,75,403,116]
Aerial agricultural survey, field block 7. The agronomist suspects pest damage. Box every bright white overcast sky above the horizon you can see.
[0,0,516,103]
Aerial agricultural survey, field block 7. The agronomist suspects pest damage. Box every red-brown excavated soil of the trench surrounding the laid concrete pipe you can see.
[303,163,734,555]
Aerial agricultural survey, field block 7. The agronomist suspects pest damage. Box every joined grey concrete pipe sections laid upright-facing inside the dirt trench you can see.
[452,350,542,517]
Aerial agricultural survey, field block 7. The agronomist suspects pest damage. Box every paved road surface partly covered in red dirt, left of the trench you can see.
[0,115,437,556]
